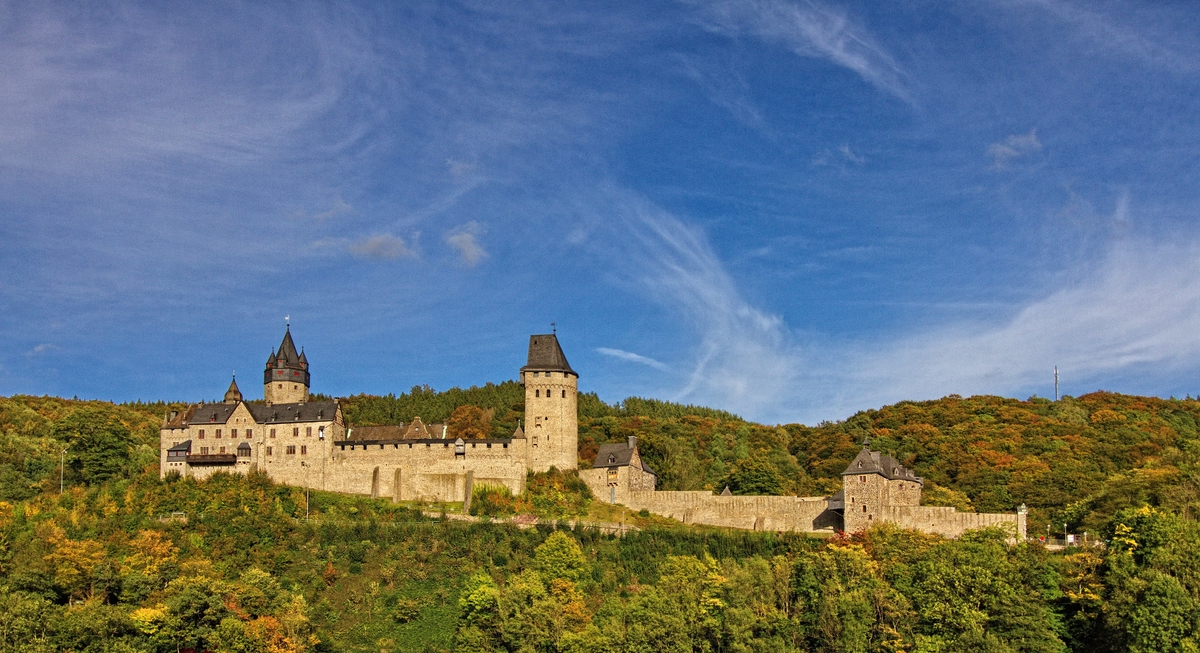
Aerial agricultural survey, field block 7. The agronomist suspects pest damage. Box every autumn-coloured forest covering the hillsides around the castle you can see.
[0,384,1200,652]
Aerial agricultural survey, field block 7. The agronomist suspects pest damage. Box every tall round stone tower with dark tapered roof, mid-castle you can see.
[521,334,580,472]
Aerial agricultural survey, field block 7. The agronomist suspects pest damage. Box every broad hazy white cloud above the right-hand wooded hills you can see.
[830,242,1200,411]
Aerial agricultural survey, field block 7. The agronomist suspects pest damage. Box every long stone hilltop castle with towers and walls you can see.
[160,327,1026,539]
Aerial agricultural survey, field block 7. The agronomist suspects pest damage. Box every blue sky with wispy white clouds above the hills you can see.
[0,0,1200,424]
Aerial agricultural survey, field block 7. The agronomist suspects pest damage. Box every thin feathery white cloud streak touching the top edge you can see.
[685,0,912,102]
